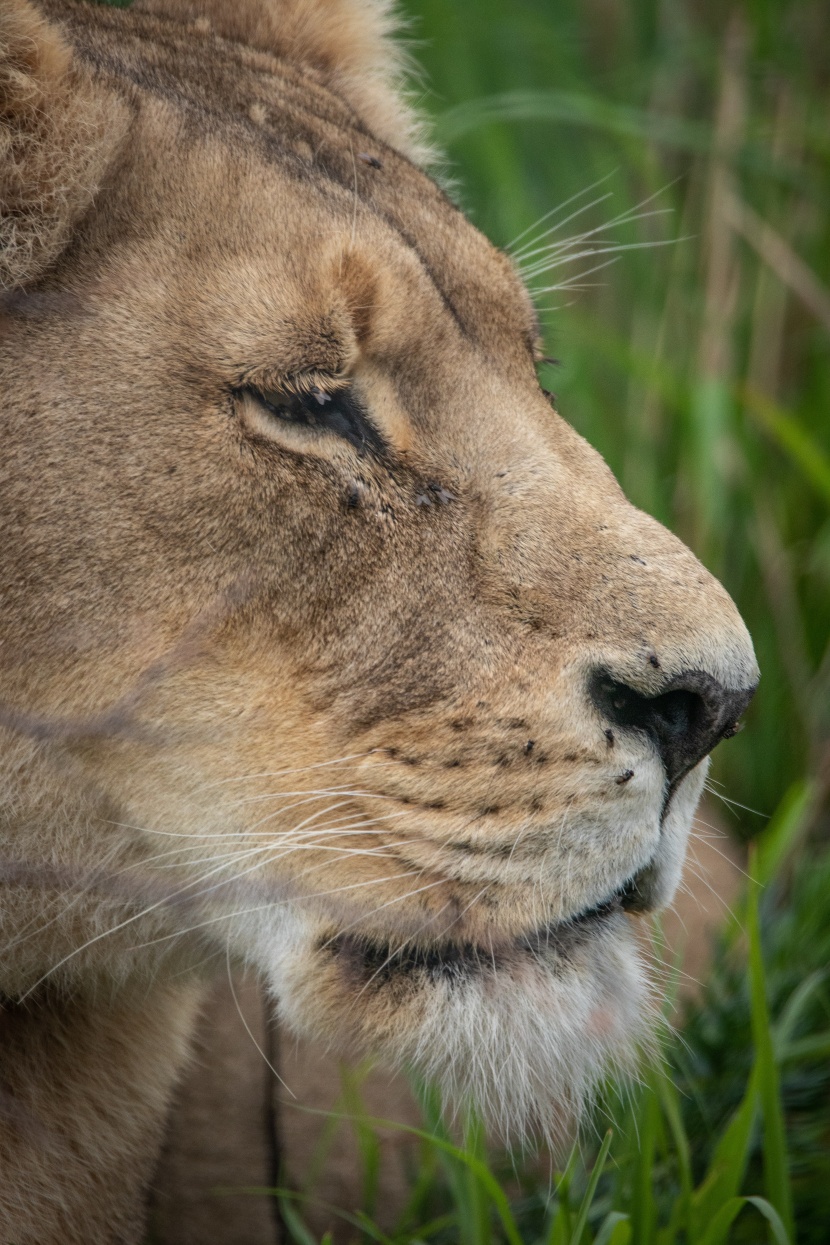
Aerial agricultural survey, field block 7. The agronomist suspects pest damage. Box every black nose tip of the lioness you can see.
[591,670,755,784]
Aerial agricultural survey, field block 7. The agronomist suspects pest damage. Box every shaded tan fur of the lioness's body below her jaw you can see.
[0,982,199,1245]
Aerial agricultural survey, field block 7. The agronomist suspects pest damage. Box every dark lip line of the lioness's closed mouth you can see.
[326,874,638,987]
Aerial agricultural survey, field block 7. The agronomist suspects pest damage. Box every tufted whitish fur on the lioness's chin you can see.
[250,911,653,1144]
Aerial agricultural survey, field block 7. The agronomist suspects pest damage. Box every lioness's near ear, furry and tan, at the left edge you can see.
[0,0,128,289]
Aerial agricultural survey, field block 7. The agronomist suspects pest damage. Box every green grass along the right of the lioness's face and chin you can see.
[270,0,830,1245]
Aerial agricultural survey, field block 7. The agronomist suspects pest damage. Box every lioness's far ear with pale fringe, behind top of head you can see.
[133,0,431,163]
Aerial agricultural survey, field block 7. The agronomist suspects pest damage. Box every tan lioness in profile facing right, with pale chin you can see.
[0,0,757,1245]
